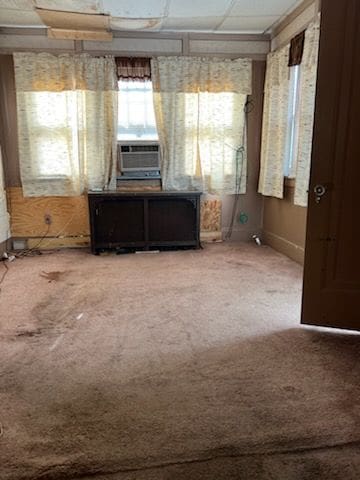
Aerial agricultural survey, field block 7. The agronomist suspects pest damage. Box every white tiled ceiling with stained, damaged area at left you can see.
[0,0,301,33]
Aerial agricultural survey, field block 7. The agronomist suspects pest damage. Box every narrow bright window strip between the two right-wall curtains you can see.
[284,65,300,178]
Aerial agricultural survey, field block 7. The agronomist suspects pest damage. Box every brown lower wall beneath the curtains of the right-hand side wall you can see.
[263,184,307,264]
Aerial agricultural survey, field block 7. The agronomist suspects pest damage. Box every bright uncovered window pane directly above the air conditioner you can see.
[117,80,158,141]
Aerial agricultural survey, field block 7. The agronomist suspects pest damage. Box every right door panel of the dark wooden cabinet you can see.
[148,198,197,244]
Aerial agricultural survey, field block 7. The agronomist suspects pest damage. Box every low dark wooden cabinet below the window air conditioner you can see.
[88,192,201,253]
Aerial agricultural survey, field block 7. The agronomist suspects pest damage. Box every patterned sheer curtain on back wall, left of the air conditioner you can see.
[14,53,118,196]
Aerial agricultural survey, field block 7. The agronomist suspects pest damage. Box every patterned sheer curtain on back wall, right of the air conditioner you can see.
[151,57,251,194]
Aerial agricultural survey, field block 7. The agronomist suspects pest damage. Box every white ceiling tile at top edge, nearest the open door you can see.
[229,0,300,17]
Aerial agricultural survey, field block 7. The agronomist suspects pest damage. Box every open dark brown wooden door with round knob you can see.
[302,0,360,329]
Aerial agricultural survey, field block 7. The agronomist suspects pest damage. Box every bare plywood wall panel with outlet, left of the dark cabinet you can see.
[8,187,90,237]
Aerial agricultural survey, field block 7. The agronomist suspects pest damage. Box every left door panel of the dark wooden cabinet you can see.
[94,198,145,246]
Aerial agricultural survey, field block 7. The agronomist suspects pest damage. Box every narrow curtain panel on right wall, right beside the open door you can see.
[294,20,320,207]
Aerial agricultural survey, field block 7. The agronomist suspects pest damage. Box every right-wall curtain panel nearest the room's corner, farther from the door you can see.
[259,45,290,198]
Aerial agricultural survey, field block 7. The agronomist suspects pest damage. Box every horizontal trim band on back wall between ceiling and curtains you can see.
[0,27,271,60]
